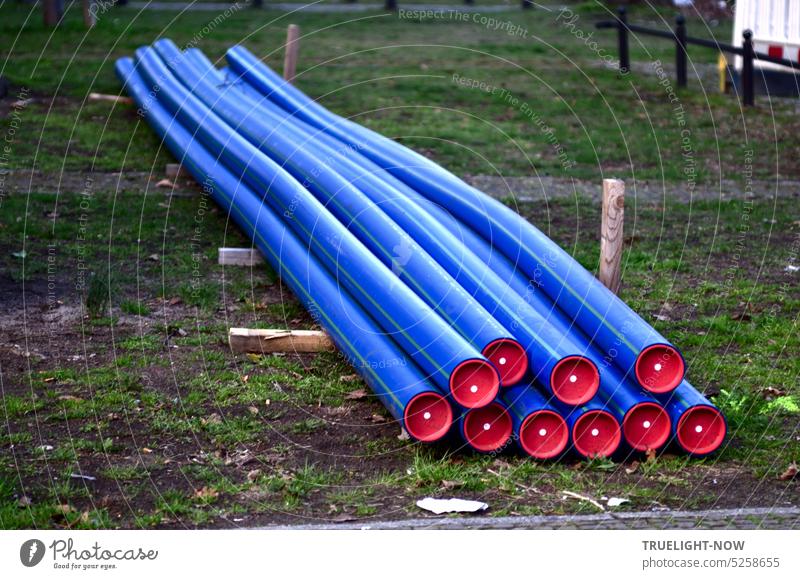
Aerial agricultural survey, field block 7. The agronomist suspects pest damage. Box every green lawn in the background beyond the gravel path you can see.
[0,3,800,181]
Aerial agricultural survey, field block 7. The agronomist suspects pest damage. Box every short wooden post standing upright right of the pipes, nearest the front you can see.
[597,179,625,293]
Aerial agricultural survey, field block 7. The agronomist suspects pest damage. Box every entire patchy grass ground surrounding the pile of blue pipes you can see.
[0,5,800,528]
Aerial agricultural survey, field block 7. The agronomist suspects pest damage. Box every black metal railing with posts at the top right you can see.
[595,6,800,106]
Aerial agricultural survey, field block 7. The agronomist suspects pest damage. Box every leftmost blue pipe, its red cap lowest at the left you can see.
[116,58,452,442]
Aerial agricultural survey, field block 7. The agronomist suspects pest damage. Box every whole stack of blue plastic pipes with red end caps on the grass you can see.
[116,39,727,459]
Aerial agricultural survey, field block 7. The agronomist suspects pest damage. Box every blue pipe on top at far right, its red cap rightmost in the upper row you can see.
[227,46,685,393]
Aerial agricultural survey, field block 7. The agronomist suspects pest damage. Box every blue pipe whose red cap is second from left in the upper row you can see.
[154,40,528,384]
